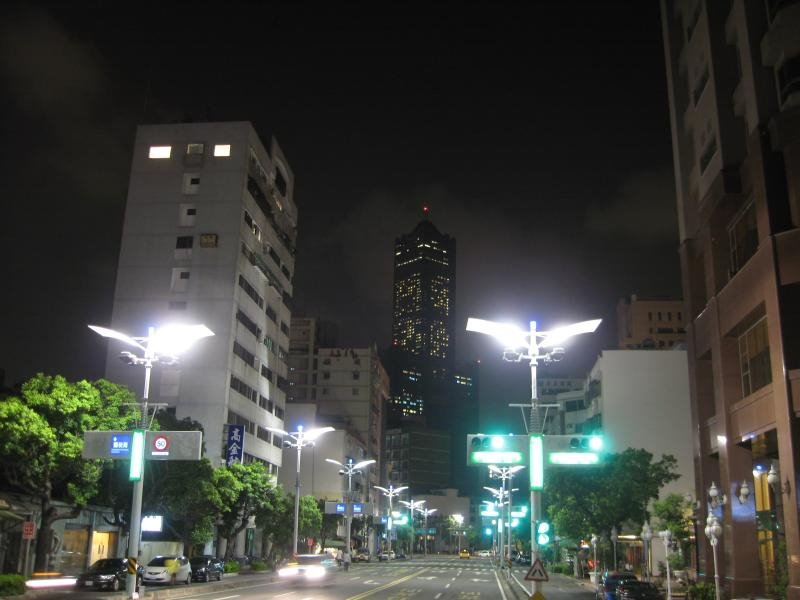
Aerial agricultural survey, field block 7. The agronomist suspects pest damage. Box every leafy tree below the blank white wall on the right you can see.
[544,448,679,541]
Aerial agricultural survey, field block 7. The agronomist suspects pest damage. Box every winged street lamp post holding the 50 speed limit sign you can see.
[89,325,214,598]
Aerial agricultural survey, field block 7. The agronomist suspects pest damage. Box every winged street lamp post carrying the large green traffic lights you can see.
[467,318,601,595]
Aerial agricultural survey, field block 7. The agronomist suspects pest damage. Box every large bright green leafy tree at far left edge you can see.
[0,373,138,571]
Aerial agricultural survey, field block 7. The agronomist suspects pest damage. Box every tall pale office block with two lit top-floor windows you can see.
[106,122,297,474]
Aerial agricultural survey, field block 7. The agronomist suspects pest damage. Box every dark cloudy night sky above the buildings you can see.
[0,0,680,428]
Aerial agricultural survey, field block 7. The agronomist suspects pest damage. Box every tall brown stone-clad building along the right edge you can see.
[661,0,800,599]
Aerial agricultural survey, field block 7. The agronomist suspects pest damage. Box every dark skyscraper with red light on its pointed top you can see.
[390,210,456,427]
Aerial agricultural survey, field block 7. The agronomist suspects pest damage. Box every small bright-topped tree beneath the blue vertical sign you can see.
[217,462,273,560]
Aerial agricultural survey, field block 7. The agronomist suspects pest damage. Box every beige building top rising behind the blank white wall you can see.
[617,294,686,350]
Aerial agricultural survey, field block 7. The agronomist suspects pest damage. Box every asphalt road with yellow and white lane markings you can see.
[25,556,594,600]
